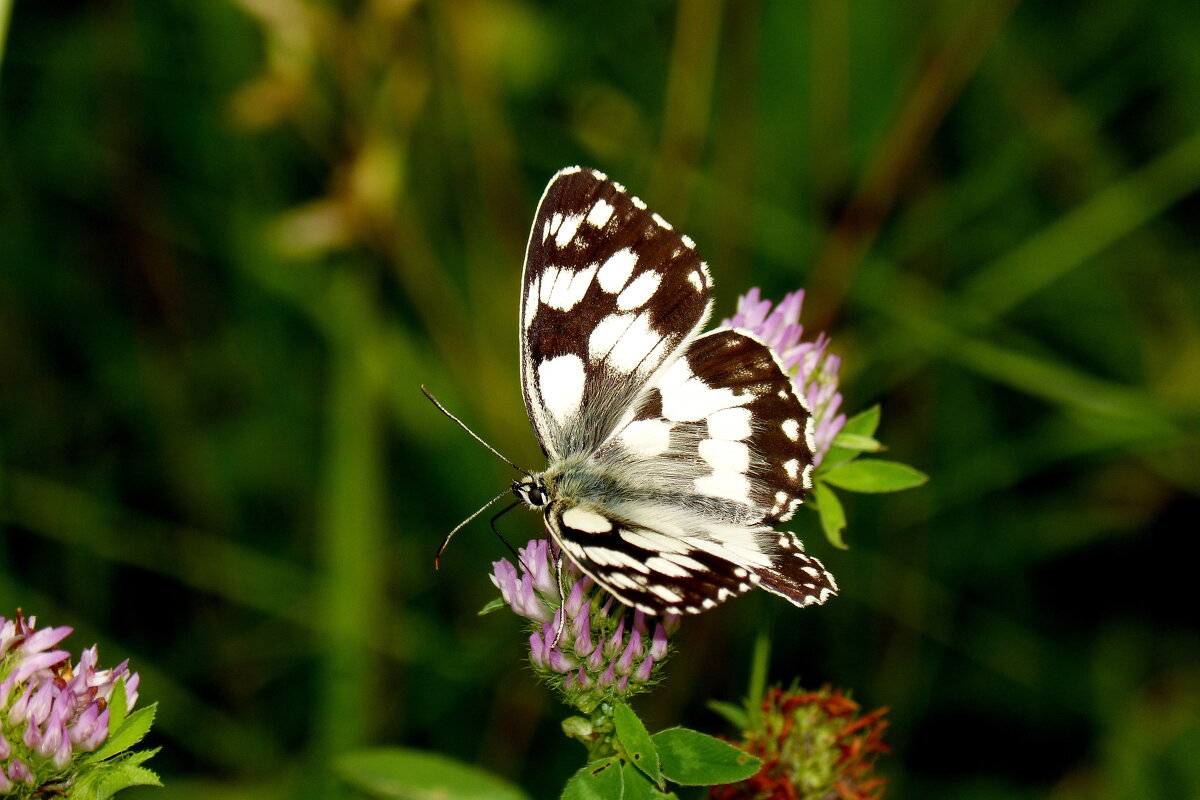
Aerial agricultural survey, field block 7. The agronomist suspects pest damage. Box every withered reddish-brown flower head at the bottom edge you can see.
[709,686,888,800]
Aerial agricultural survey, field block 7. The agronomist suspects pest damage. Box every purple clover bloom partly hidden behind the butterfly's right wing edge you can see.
[721,287,846,464]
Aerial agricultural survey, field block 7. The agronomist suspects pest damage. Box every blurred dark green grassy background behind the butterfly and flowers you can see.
[0,0,1200,800]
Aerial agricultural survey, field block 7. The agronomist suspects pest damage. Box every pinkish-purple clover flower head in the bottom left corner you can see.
[0,610,139,795]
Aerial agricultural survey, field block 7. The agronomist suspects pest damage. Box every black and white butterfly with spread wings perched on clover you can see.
[434,167,838,614]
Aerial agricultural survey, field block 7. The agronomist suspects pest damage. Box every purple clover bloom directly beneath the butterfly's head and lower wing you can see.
[491,539,679,714]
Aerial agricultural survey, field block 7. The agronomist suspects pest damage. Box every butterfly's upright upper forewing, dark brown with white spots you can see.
[520,167,712,459]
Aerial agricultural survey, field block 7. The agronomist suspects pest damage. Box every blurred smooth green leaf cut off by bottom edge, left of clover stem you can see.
[334,747,528,800]
